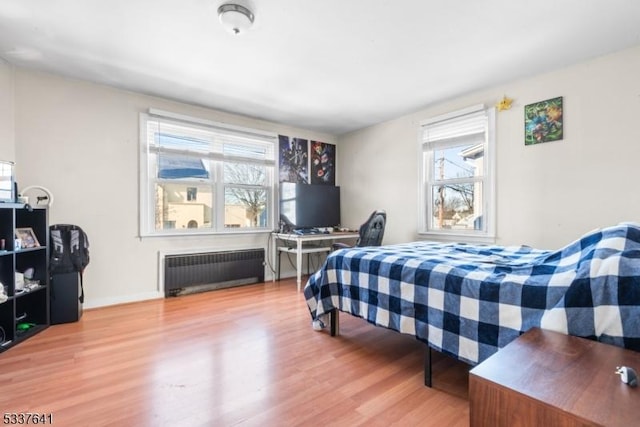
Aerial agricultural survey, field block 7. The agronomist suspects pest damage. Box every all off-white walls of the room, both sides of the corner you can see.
[8,42,640,307]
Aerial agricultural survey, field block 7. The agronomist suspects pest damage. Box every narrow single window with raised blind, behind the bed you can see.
[420,106,495,241]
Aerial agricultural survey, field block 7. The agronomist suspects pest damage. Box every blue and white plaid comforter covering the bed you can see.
[304,223,640,364]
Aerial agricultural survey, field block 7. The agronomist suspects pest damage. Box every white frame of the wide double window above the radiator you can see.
[139,108,278,237]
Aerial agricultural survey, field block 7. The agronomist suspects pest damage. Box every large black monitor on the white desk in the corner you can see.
[280,182,340,229]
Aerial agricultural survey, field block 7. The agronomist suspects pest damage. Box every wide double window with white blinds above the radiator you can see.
[140,110,277,235]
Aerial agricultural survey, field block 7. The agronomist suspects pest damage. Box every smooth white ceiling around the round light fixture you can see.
[0,0,640,134]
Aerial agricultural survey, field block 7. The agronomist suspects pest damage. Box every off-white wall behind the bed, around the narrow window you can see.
[338,46,640,249]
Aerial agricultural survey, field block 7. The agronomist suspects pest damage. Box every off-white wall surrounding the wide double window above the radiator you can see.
[11,69,335,307]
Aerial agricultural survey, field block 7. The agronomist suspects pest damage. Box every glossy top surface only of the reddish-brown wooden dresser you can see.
[470,328,640,426]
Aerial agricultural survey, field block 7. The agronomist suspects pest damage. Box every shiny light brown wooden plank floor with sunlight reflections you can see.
[0,280,469,427]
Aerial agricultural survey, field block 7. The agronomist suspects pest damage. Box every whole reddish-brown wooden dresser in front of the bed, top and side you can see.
[469,328,640,427]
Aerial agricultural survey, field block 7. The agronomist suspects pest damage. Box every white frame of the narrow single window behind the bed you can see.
[418,105,496,243]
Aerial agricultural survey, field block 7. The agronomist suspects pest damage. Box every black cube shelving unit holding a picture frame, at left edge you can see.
[0,203,50,352]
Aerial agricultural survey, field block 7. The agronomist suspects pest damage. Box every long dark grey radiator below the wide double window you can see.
[164,249,264,297]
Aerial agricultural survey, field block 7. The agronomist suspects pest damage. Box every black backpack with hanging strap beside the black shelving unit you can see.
[49,224,89,302]
